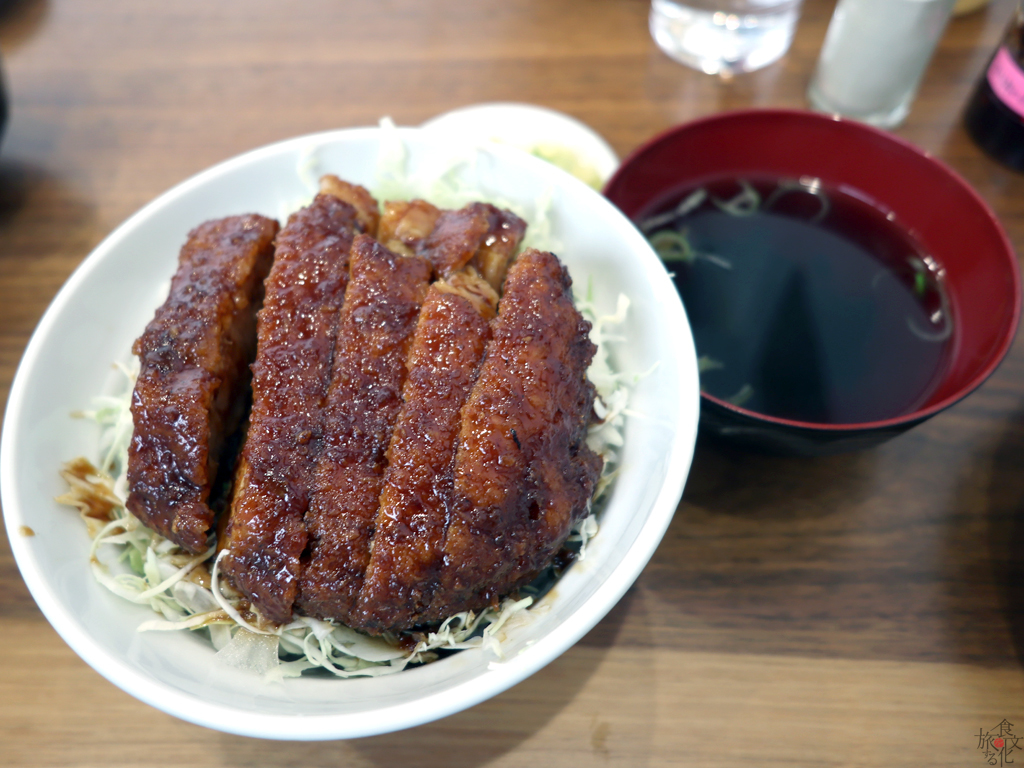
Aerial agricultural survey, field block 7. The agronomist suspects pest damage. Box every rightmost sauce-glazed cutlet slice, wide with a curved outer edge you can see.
[423,249,602,621]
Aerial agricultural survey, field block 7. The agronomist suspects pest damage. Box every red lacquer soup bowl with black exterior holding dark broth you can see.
[605,110,1021,455]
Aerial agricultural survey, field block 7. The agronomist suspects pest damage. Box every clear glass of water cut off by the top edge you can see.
[650,0,803,75]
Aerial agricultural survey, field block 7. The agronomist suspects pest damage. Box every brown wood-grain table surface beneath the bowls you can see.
[0,0,1024,768]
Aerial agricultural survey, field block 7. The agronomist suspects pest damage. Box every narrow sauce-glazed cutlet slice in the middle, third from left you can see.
[295,237,431,622]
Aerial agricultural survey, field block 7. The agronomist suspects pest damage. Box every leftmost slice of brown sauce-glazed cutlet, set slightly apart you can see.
[127,215,278,553]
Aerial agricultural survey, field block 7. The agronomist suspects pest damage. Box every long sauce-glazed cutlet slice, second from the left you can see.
[221,194,361,623]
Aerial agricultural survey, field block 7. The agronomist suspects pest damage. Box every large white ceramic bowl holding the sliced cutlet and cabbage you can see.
[0,128,698,739]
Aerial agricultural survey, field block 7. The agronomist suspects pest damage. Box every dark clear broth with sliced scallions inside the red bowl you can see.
[637,176,954,424]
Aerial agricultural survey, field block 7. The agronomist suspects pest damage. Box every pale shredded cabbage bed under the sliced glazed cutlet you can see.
[57,120,629,680]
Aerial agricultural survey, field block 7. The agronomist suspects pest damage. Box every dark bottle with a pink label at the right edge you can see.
[964,0,1024,171]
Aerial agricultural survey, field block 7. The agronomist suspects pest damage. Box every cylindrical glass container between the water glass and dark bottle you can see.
[807,0,955,128]
